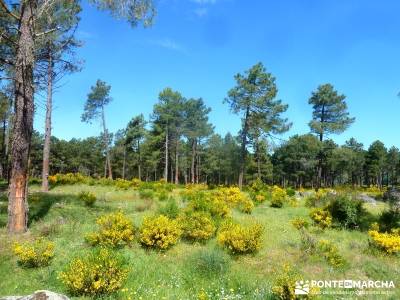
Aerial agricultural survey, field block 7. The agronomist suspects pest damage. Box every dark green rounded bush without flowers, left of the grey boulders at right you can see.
[327,195,366,228]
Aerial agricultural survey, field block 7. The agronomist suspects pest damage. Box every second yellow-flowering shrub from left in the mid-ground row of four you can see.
[140,215,182,250]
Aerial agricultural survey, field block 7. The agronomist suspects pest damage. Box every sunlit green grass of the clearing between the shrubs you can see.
[0,185,400,299]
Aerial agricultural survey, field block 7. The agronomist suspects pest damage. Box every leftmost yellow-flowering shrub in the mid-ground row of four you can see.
[86,212,134,247]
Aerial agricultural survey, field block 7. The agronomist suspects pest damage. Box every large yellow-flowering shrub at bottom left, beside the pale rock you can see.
[59,249,128,296]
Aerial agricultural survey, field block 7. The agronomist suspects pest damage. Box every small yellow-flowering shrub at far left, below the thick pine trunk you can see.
[13,239,54,268]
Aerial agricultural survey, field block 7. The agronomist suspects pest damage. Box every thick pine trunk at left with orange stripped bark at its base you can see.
[7,1,36,233]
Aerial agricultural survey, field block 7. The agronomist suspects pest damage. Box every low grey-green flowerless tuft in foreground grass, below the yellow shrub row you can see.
[186,249,230,277]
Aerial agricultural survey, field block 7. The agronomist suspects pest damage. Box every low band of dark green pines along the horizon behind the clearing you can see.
[25,130,400,187]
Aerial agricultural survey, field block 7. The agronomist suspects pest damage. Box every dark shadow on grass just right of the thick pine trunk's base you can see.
[28,193,77,226]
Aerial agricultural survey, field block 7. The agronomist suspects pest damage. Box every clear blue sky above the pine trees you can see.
[35,0,400,148]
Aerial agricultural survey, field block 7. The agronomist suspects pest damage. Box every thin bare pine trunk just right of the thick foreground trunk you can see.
[42,53,53,192]
